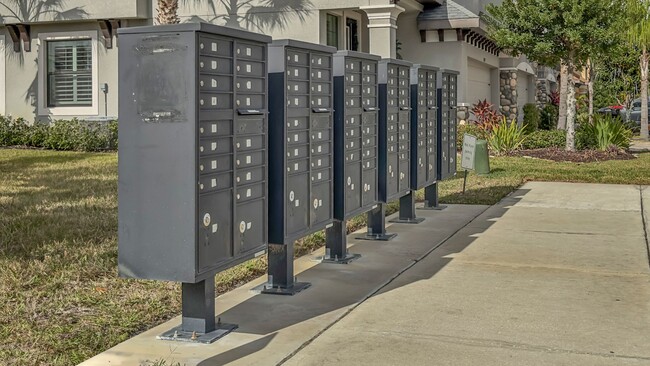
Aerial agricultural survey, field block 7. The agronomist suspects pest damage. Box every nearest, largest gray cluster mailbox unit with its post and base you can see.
[118,23,271,342]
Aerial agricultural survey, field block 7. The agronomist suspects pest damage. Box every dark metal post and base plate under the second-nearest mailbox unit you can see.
[262,241,311,295]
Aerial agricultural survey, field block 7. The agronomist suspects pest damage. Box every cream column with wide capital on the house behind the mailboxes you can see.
[359,5,404,58]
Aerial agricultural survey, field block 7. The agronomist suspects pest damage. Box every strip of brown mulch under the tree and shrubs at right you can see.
[511,147,636,163]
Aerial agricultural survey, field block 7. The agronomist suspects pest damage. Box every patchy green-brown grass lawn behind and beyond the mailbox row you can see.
[0,149,650,365]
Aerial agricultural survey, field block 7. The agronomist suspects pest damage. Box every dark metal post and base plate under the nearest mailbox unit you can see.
[158,276,237,343]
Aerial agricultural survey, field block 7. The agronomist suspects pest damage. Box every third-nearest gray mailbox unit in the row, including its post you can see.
[326,51,380,263]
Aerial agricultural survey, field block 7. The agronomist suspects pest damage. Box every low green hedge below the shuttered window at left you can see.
[0,116,117,151]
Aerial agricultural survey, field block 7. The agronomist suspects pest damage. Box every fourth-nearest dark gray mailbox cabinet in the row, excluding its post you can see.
[377,59,412,203]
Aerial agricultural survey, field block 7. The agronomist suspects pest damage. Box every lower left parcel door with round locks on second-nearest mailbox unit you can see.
[285,174,310,236]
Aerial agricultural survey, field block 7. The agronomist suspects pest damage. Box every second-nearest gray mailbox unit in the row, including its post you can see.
[262,40,336,294]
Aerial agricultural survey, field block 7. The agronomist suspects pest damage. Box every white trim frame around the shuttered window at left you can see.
[38,31,99,116]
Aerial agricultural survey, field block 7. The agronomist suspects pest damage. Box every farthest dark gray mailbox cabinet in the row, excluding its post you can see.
[438,69,459,180]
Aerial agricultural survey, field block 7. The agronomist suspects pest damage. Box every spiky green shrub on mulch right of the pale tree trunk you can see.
[576,114,632,151]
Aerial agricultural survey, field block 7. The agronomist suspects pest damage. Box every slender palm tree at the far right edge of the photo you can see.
[627,0,650,140]
